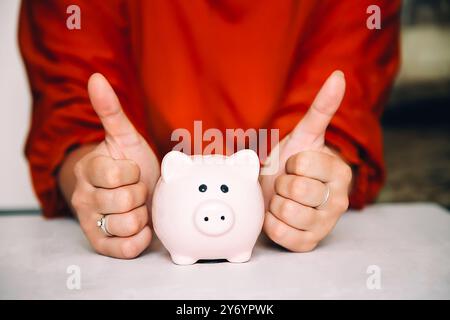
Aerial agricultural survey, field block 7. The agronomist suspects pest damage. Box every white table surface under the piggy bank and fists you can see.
[0,204,450,299]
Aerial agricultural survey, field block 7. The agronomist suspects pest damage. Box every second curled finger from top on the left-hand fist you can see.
[94,182,147,214]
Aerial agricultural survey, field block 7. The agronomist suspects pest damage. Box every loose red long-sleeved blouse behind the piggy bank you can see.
[19,0,400,217]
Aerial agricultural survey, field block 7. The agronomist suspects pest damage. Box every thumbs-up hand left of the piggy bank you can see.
[71,74,159,258]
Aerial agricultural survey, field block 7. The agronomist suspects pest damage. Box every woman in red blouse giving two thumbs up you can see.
[19,0,400,258]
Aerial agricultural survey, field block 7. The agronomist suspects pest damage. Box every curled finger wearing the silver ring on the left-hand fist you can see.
[105,205,148,237]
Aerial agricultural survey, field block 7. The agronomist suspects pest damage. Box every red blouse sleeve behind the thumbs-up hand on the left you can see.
[19,0,148,217]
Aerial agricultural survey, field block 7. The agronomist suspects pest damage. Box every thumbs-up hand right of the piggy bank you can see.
[260,71,352,252]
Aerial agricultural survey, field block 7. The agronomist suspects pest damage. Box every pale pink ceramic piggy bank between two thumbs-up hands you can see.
[152,150,264,265]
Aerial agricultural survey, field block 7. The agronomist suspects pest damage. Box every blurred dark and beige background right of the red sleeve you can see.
[378,0,450,209]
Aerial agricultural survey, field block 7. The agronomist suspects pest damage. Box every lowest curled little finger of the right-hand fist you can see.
[264,212,318,252]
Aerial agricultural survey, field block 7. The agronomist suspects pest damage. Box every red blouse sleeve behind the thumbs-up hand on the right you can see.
[273,0,400,208]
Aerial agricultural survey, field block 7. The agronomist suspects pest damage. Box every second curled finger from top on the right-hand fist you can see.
[275,174,327,207]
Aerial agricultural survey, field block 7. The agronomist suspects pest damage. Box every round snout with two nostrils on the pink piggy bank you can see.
[194,200,234,236]
